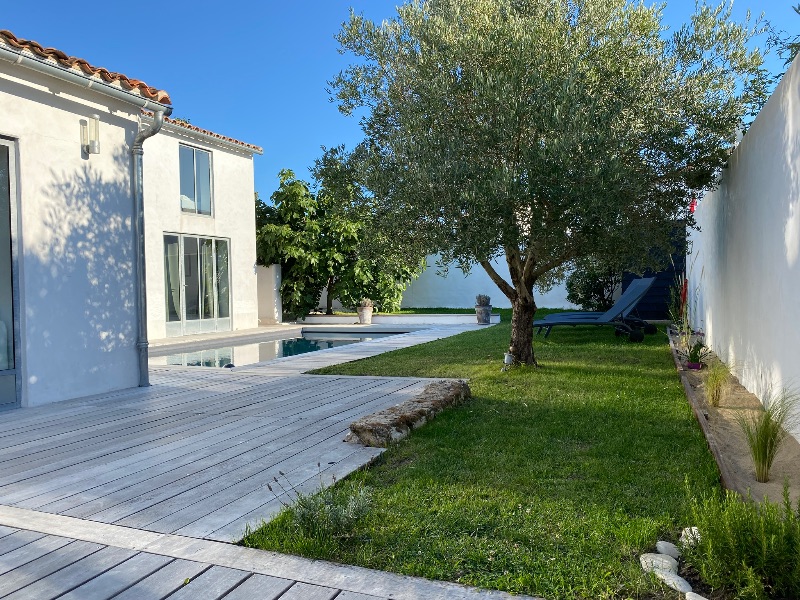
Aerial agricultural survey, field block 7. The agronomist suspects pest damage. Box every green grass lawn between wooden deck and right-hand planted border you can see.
[245,311,717,600]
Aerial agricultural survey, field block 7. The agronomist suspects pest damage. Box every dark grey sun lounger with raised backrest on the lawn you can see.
[533,277,655,341]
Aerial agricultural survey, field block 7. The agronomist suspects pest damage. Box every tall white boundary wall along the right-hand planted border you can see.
[687,56,800,439]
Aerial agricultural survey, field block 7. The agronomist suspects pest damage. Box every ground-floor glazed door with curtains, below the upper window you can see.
[164,234,231,336]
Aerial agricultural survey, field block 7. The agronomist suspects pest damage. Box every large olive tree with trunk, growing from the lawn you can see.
[331,0,766,364]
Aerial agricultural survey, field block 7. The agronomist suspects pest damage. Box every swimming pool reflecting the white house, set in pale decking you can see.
[150,332,396,368]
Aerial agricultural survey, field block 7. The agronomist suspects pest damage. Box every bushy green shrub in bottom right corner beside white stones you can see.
[683,483,800,600]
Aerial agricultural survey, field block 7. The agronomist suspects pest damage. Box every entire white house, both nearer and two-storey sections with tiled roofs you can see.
[0,31,268,410]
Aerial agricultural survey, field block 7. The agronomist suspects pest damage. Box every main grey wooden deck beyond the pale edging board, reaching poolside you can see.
[0,327,478,542]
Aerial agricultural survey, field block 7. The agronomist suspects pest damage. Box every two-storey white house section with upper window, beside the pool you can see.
[144,116,262,340]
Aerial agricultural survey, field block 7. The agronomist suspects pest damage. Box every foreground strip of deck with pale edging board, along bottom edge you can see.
[0,505,536,600]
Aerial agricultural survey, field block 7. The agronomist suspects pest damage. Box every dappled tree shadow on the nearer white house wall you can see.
[28,147,137,371]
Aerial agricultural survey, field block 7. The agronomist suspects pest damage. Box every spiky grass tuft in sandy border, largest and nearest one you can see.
[736,389,800,483]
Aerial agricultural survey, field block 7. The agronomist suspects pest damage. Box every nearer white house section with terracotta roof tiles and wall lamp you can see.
[0,31,170,407]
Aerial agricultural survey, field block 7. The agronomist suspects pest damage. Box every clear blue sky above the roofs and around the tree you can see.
[0,0,800,198]
